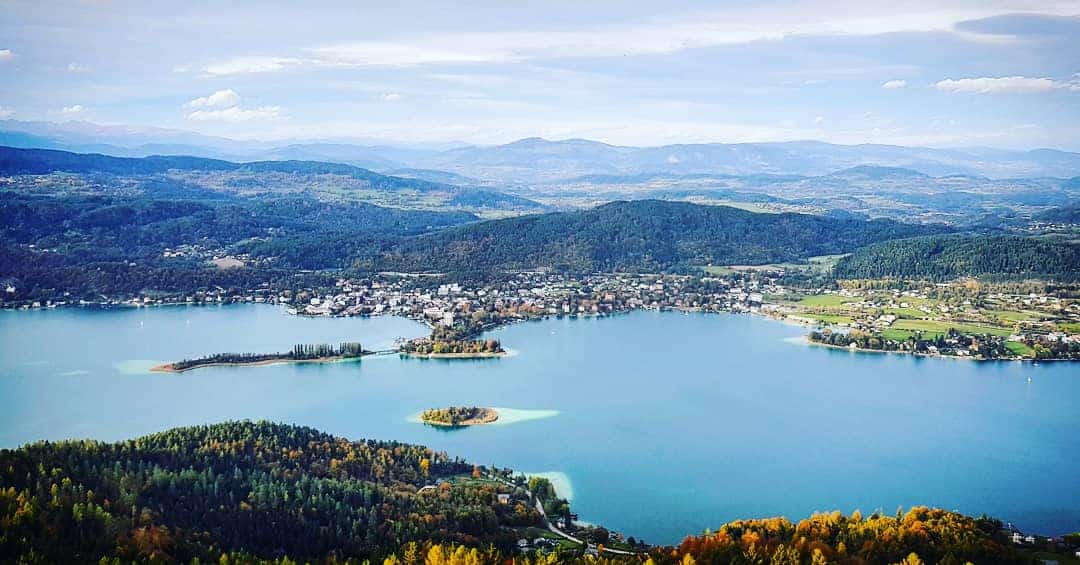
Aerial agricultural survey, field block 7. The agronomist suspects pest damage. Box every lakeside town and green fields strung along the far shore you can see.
[3,266,1080,361]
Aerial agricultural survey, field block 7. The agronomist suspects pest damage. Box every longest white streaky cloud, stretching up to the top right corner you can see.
[190,0,1076,70]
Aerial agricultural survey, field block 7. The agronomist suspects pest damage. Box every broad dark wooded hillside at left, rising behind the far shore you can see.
[0,190,477,300]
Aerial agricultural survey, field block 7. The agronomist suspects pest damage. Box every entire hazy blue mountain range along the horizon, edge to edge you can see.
[0,120,1080,184]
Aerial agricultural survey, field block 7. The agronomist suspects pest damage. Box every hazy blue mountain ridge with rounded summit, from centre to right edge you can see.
[414,138,1080,181]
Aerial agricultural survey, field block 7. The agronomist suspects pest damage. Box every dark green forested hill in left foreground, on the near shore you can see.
[0,422,541,563]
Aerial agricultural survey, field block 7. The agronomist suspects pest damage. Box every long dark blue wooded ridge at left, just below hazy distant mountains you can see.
[0,147,454,191]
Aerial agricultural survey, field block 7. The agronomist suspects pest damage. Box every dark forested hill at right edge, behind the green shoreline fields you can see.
[835,236,1080,281]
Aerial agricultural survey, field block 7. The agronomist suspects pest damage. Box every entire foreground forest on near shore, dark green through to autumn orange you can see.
[0,422,1049,565]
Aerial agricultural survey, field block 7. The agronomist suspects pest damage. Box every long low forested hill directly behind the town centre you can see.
[381,200,947,271]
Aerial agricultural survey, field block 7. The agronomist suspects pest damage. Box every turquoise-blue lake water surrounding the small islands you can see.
[0,305,1080,542]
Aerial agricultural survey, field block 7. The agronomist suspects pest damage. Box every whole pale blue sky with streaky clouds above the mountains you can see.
[0,0,1080,150]
